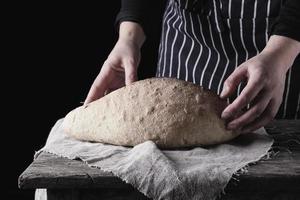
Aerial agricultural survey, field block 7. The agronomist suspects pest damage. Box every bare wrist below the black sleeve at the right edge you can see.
[262,35,300,71]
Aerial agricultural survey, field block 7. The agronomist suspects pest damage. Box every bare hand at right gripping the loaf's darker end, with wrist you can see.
[221,35,300,132]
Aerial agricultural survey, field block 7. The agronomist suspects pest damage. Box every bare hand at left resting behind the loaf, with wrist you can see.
[84,22,145,105]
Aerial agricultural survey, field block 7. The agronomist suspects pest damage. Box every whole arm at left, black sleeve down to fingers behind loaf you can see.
[84,0,150,104]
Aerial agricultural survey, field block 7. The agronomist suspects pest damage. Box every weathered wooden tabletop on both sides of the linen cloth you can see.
[19,120,300,192]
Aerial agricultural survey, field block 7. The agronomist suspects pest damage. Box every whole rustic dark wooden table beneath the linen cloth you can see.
[19,120,300,200]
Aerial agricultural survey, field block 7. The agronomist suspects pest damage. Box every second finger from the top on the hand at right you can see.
[221,72,263,119]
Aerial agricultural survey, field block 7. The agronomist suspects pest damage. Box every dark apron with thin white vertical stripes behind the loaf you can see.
[156,0,300,119]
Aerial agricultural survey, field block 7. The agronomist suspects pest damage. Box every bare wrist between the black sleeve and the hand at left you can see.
[119,21,146,48]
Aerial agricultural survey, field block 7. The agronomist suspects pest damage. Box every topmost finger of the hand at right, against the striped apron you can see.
[220,66,247,98]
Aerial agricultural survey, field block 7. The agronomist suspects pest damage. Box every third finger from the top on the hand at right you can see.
[227,90,271,130]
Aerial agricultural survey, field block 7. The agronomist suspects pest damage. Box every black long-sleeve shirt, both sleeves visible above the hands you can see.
[116,0,300,41]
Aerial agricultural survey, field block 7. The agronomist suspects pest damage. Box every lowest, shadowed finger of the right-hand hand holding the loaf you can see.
[242,99,280,133]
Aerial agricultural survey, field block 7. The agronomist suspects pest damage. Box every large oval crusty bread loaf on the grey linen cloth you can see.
[63,78,239,148]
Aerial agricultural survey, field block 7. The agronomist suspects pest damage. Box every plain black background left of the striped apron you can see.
[1,1,162,199]
